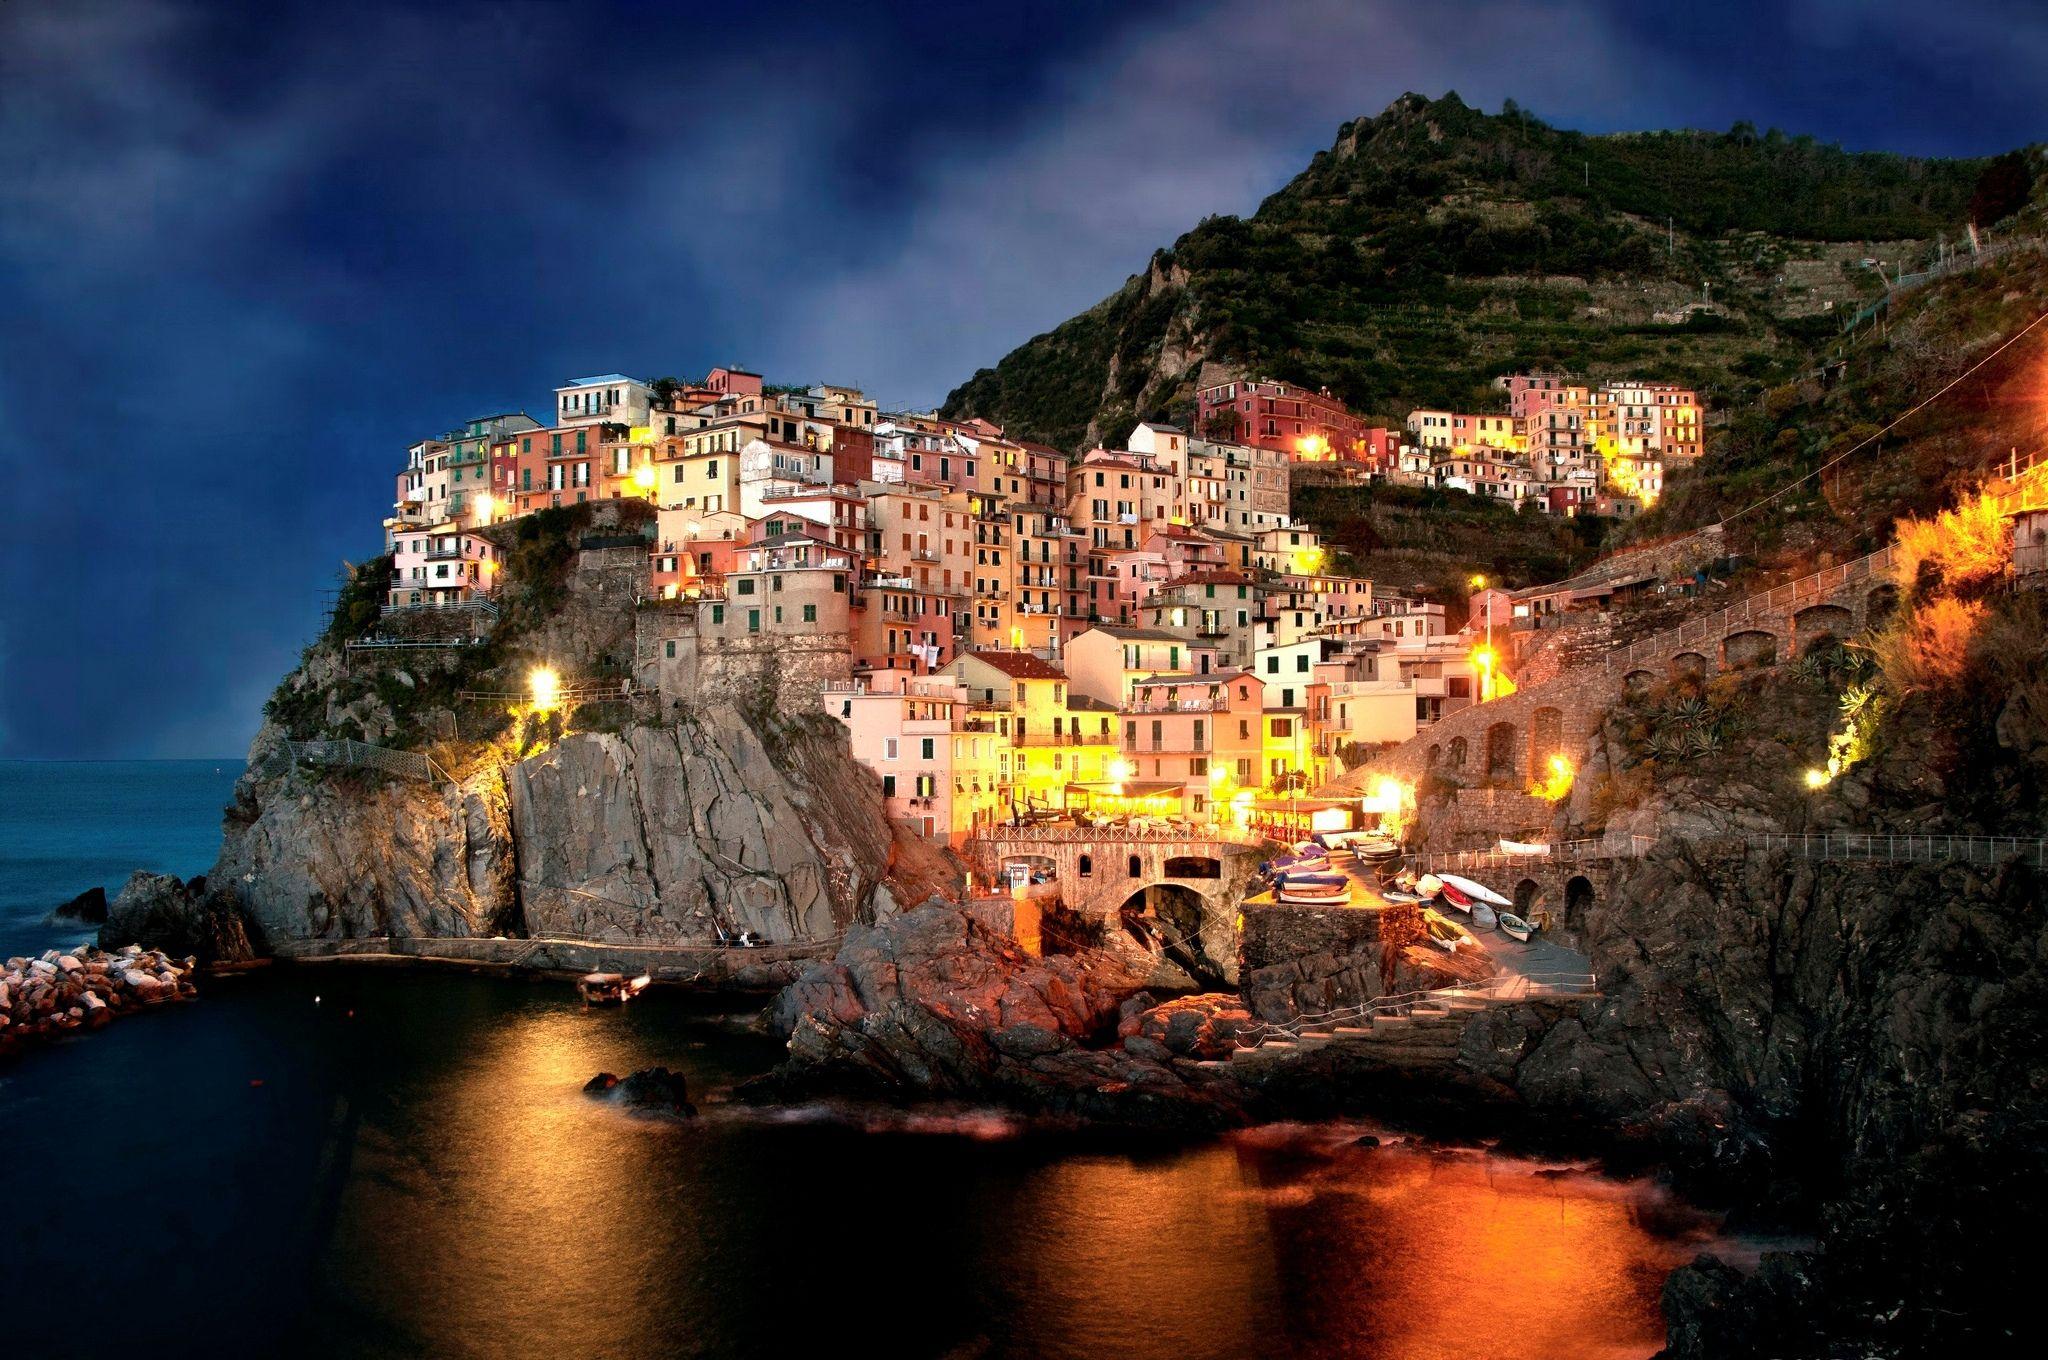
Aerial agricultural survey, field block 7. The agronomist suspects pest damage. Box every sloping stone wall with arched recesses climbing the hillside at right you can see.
[1337,547,1896,793]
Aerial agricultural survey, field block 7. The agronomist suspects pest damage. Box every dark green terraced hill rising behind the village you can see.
[942,94,1987,449]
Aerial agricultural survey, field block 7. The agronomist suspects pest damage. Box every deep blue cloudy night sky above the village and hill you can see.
[0,0,2048,758]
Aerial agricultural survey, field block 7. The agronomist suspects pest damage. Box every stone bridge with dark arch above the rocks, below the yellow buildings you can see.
[967,825,1268,981]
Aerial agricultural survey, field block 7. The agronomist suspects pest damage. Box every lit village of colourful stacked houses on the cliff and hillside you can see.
[383,369,1704,848]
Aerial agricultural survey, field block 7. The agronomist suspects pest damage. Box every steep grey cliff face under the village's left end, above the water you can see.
[211,709,954,944]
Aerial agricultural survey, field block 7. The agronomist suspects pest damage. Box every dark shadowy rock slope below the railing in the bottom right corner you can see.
[1460,846,2048,1356]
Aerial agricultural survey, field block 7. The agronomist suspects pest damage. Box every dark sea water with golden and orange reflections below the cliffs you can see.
[0,766,1706,1360]
